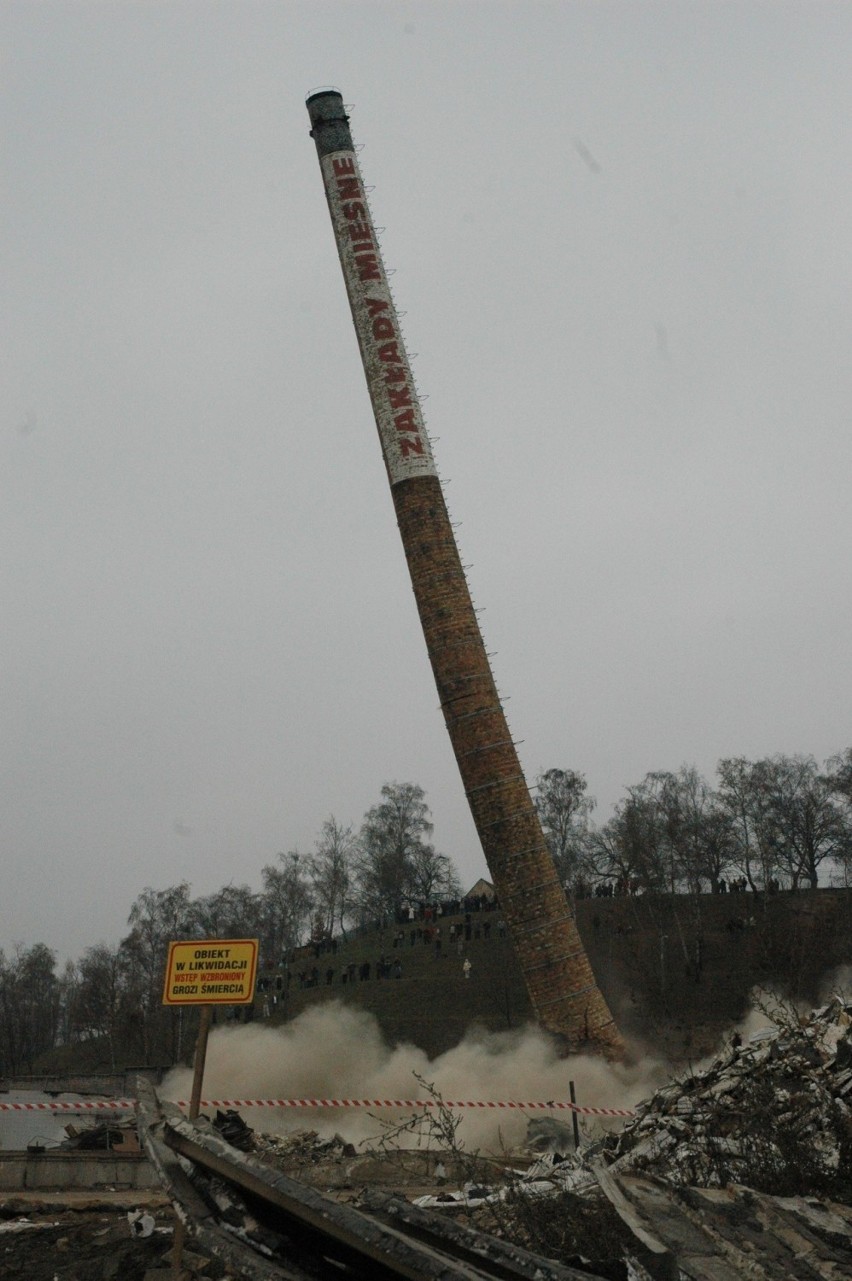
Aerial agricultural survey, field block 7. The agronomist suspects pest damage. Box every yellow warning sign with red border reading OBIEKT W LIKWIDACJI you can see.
[163,939,258,1006]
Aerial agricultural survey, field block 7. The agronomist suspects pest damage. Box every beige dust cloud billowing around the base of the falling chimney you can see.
[161,1003,670,1153]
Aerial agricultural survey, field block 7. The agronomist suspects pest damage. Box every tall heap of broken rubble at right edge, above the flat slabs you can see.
[601,998,852,1200]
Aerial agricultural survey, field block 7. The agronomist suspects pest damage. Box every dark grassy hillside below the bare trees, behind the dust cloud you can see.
[266,890,852,1061]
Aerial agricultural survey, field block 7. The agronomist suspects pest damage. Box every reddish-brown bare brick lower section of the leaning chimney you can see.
[392,477,621,1053]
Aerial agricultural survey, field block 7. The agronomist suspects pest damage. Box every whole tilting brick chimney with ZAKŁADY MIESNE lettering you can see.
[307,90,623,1056]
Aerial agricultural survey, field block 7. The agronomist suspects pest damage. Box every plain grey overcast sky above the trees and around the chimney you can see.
[0,0,852,958]
